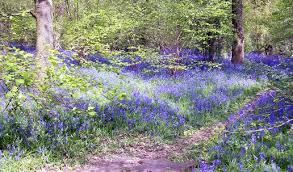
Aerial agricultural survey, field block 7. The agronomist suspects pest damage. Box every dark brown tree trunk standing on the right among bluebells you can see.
[231,0,244,64]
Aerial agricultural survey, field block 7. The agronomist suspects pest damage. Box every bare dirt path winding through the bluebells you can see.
[60,91,273,172]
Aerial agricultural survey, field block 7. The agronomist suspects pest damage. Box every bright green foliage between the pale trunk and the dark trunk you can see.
[62,0,231,53]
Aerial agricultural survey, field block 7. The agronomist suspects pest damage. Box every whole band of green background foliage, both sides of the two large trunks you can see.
[0,0,293,55]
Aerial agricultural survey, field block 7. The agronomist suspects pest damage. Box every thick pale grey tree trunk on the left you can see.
[34,0,54,80]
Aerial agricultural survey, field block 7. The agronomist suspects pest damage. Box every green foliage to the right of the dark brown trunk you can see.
[244,0,293,56]
